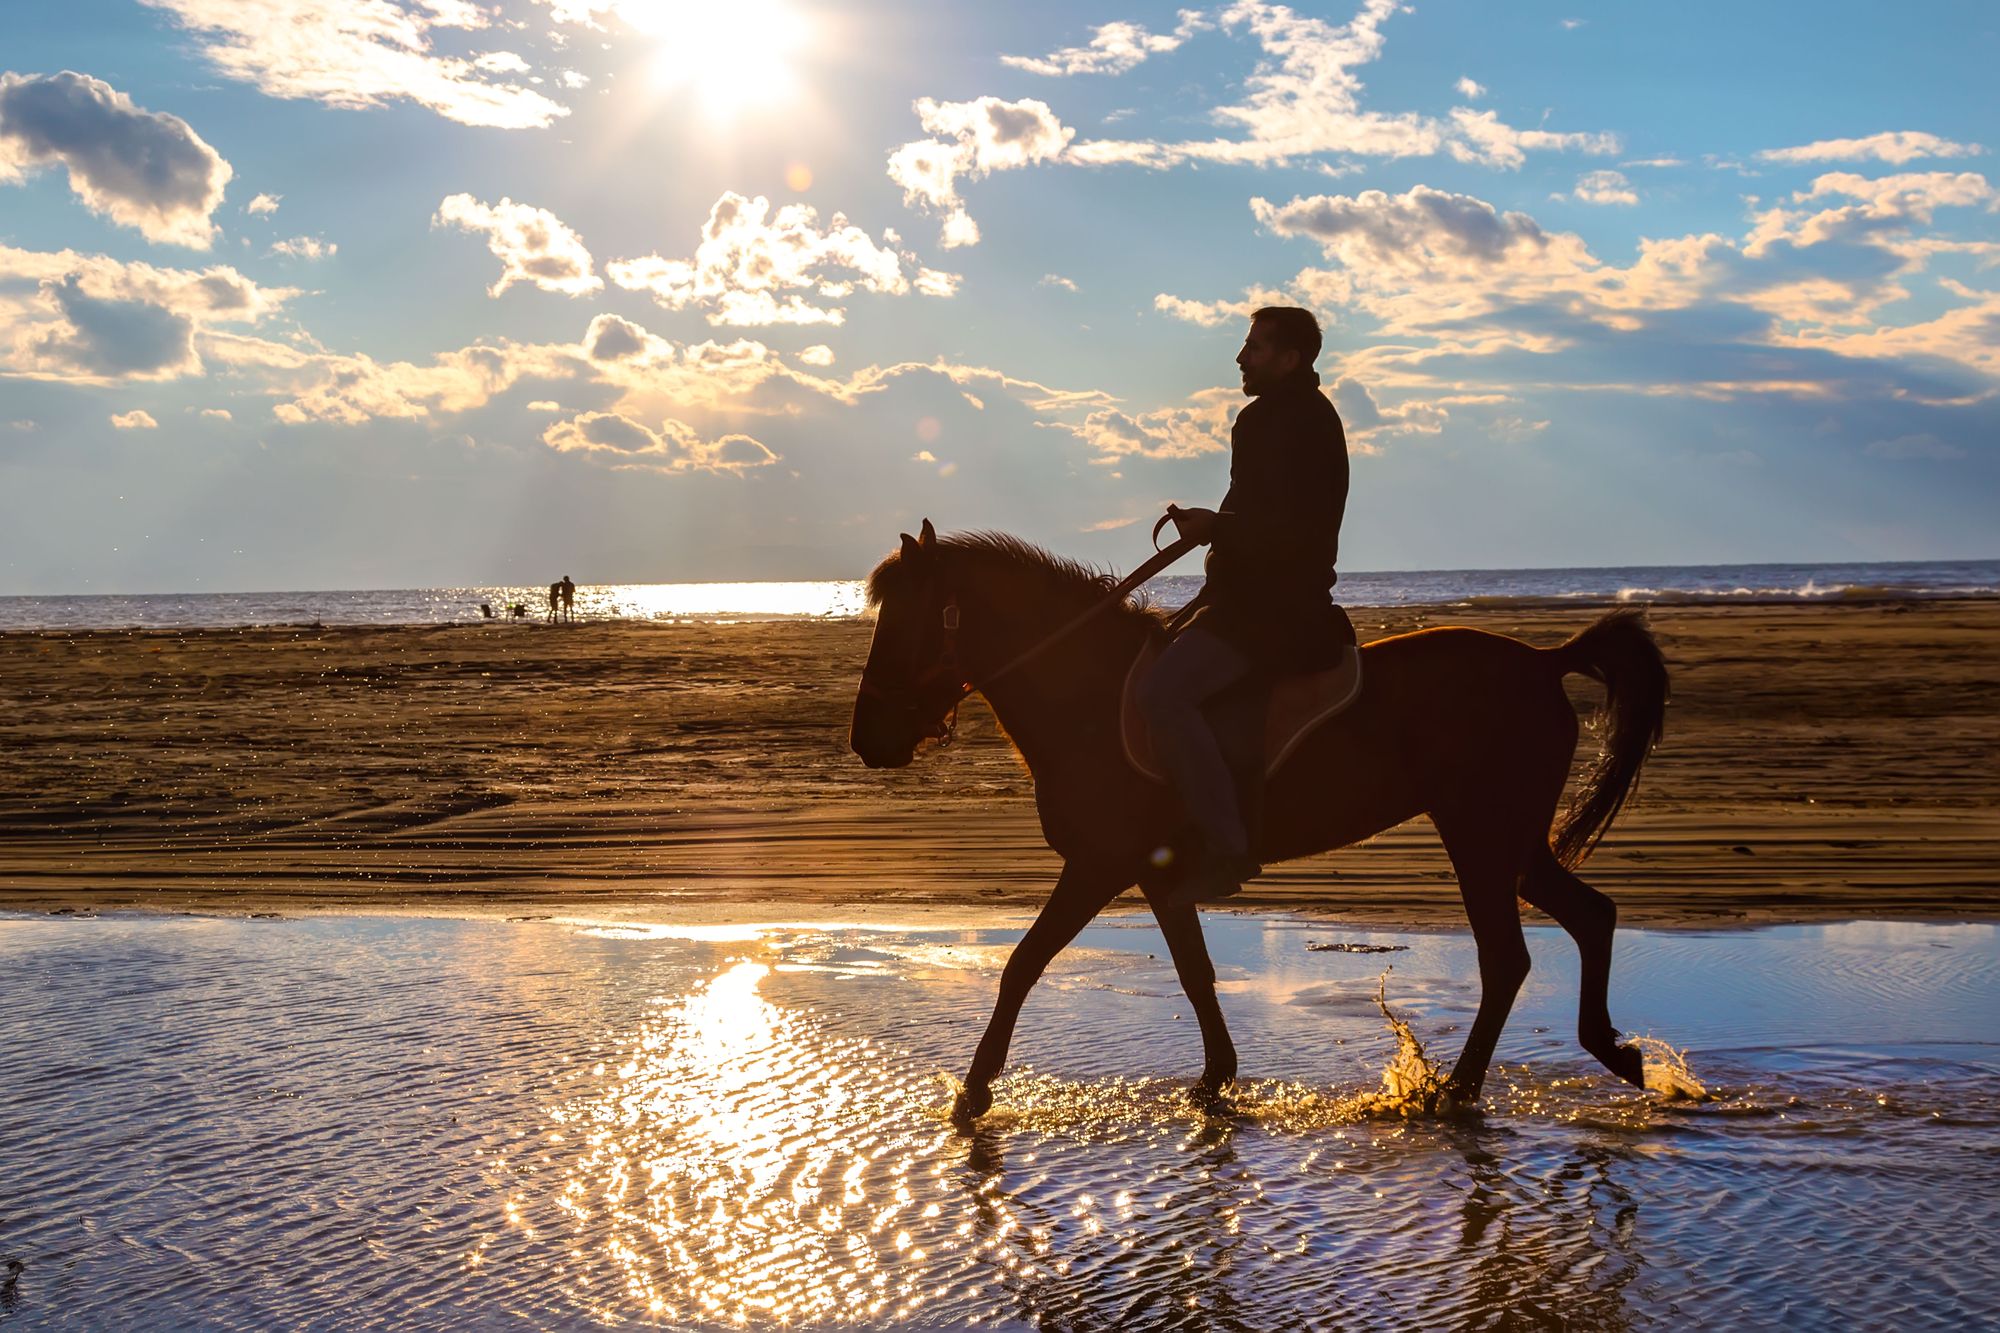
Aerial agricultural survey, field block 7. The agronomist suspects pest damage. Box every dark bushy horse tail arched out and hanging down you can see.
[1548,606,1668,871]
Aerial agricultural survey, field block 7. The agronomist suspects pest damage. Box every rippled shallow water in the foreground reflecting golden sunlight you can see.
[0,917,2000,1329]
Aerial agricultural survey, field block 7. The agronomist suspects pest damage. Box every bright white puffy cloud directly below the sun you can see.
[604,192,958,326]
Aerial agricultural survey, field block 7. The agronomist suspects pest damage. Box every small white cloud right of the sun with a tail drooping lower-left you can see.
[888,96,1076,248]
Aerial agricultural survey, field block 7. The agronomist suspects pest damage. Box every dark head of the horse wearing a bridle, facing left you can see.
[848,518,966,769]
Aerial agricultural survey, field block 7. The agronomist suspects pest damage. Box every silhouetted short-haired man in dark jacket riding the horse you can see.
[1140,306,1354,903]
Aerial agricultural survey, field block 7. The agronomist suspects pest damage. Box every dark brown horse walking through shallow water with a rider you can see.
[850,518,1668,1125]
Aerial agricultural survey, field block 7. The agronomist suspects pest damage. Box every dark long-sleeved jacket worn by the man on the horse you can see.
[1192,366,1354,675]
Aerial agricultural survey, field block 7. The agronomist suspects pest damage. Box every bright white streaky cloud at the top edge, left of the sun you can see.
[144,0,568,130]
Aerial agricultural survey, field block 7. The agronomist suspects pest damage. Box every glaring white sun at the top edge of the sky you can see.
[618,0,808,118]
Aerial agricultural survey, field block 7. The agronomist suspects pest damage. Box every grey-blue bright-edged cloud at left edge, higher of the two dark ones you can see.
[0,70,232,250]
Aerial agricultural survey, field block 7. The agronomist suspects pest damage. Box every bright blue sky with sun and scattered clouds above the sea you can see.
[0,0,2000,592]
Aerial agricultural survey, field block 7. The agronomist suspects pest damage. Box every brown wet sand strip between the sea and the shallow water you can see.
[0,602,2000,927]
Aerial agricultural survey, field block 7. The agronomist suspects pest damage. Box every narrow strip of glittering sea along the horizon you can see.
[0,560,2000,630]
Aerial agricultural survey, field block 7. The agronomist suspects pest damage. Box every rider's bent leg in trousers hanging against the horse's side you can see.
[1138,626,1256,897]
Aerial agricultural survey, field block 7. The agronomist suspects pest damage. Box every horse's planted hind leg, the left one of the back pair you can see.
[1432,813,1530,1103]
